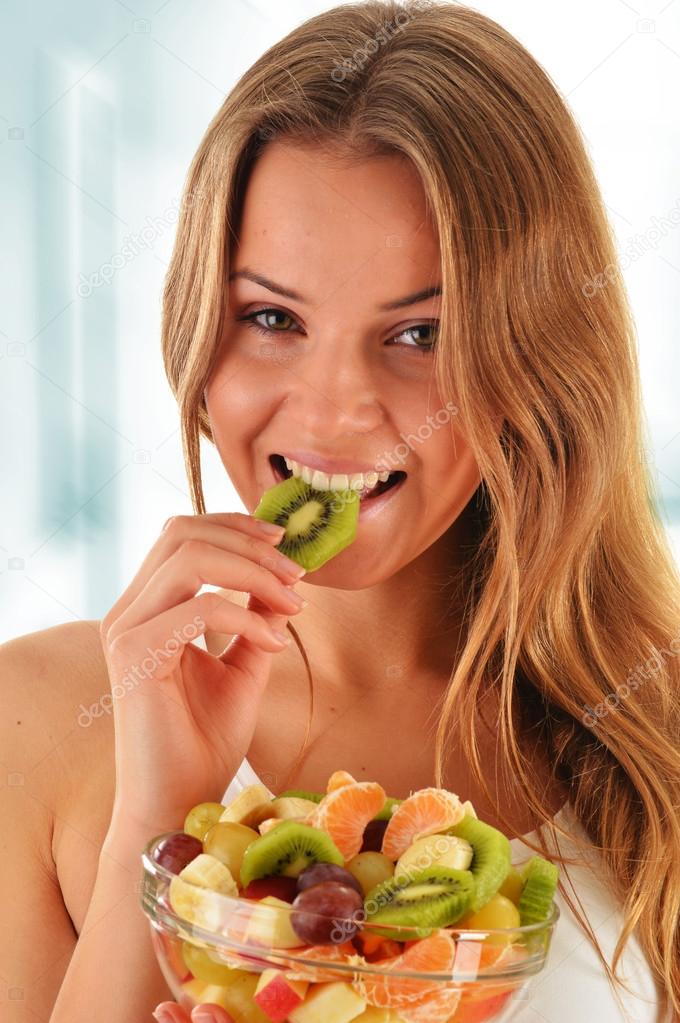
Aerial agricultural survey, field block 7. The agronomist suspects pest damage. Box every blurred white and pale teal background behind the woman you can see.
[0,0,680,641]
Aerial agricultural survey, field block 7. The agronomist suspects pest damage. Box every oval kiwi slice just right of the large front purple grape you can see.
[364,865,474,941]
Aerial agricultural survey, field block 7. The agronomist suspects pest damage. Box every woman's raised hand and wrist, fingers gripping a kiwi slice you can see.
[100,513,304,838]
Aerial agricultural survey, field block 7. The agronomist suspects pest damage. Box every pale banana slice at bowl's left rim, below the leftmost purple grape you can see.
[169,852,238,931]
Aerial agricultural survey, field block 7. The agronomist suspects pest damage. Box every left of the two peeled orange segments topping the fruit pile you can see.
[305,782,386,862]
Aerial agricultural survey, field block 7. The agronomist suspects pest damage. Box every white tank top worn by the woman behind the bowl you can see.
[189,635,672,1023]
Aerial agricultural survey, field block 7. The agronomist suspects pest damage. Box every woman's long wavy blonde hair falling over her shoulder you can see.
[163,0,680,1013]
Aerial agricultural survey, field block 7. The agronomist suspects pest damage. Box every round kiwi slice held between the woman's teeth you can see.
[253,476,360,572]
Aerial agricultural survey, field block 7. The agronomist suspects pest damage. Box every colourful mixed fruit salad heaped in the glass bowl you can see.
[145,770,558,1023]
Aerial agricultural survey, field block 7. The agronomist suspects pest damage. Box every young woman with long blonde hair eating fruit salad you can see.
[0,0,680,1023]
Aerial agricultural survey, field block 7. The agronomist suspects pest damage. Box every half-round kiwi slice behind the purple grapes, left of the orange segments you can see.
[240,820,345,888]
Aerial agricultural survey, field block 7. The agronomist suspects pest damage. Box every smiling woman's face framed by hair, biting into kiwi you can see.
[206,142,481,588]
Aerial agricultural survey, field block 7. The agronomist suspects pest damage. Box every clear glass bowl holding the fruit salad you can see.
[141,832,559,1023]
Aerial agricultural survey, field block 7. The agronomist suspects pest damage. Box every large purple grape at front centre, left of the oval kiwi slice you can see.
[290,881,364,945]
